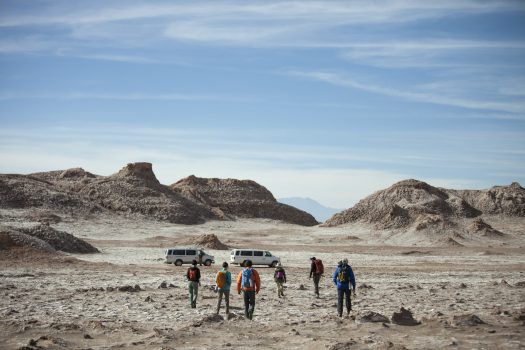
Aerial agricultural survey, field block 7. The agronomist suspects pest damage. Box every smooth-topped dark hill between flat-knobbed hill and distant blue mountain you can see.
[170,175,317,226]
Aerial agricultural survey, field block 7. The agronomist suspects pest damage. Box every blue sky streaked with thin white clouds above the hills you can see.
[0,0,525,208]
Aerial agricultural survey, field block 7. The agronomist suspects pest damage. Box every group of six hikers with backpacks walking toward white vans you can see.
[186,257,355,320]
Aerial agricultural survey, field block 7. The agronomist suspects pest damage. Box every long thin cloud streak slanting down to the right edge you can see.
[288,71,525,114]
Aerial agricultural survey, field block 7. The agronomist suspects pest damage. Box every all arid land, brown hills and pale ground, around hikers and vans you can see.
[0,167,525,350]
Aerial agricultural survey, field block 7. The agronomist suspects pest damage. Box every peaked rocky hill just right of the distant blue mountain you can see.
[325,180,481,230]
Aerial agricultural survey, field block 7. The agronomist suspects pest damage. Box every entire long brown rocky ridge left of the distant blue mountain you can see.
[0,163,317,226]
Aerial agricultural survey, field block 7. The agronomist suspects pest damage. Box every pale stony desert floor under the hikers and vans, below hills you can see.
[0,211,525,349]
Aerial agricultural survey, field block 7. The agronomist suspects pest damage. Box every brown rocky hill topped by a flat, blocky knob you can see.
[75,163,217,224]
